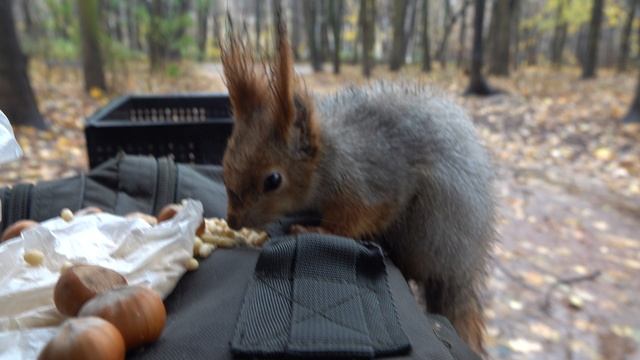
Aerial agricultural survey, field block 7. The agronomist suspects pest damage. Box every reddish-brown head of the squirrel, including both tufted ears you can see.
[222,12,319,228]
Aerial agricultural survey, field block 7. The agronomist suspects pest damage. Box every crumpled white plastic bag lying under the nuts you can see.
[0,200,202,360]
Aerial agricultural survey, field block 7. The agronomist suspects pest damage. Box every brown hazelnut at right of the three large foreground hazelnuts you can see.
[78,286,167,349]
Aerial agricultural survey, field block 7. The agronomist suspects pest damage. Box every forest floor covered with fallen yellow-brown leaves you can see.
[0,64,640,360]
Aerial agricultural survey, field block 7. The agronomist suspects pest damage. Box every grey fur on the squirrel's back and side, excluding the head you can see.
[309,83,495,330]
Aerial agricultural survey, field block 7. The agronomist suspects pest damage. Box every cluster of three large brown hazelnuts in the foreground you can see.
[38,265,167,360]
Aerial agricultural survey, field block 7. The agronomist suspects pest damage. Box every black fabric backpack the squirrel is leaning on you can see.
[0,154,479,360]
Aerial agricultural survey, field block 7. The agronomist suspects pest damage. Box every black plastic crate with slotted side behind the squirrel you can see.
[85,94,233,168]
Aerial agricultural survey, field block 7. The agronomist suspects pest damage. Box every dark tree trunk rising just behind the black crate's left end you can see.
[77,0,107,91]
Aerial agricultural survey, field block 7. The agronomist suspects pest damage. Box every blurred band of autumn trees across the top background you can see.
[0,0,640,124]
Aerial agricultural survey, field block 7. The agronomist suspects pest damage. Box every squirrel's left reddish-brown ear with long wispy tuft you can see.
[220,13,270,121]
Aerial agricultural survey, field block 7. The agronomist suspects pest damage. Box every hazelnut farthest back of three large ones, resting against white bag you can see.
[53,265,127,316]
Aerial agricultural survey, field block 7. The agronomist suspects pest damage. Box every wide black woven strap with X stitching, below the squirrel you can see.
[231,234,410,358]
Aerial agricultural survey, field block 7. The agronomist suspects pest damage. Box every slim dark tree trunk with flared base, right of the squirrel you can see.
[466,0,494,96]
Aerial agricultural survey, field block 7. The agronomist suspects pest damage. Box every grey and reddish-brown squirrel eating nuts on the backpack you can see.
[221,14,496,354]
